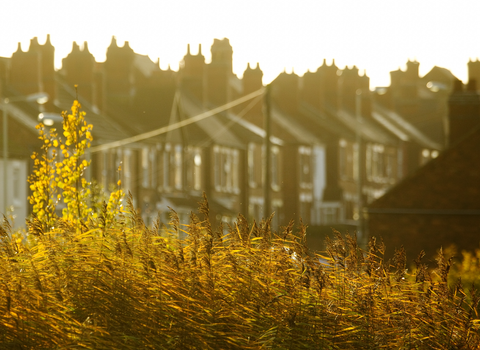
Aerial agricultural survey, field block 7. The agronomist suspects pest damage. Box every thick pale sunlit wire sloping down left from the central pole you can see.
[89,88,265,153]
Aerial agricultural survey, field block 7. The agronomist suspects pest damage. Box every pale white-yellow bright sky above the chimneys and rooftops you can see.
[0,0,480,88]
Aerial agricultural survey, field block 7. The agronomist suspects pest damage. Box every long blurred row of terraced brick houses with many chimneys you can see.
[0,38,448,242]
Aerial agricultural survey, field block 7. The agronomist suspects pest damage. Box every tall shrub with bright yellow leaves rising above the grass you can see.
[28,100,123,231]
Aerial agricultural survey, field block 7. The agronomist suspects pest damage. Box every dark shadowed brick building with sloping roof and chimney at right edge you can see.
[368,79,480,259]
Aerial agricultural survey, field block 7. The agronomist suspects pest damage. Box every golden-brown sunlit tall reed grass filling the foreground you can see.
[0,194,480,349]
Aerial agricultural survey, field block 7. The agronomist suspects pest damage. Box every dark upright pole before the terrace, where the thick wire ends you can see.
[263,84,272,218]
